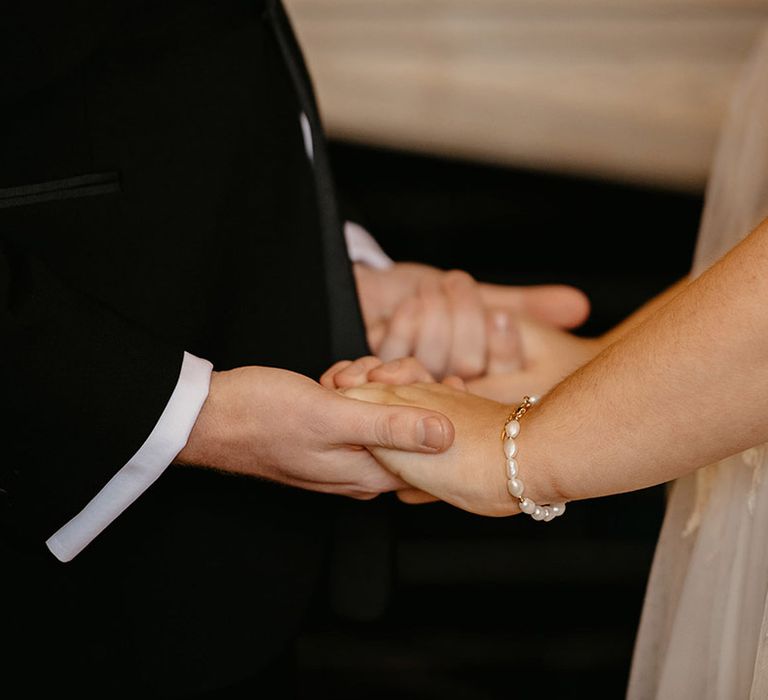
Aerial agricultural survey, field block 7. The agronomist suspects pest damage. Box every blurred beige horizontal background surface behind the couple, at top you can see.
[285,0,768,190]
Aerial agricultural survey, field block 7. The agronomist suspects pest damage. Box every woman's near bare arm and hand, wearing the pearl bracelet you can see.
[344,216,768,515]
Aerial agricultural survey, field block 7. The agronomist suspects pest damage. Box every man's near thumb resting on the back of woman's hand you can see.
[332,396,454,453]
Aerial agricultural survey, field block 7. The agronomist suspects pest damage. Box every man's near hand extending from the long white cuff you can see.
[175,367,454,499]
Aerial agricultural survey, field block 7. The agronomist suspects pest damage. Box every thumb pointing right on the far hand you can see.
[480,284,589,328]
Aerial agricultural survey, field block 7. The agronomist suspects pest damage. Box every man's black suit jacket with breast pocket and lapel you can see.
[0,0,382,697]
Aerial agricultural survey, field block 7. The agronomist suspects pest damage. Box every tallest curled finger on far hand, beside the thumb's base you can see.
[443,270,486,379]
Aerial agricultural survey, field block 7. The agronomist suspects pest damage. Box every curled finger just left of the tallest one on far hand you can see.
[412,280,452,377]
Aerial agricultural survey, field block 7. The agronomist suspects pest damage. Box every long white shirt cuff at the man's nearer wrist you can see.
[46,352,213,562]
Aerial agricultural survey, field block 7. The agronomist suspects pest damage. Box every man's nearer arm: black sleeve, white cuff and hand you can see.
[0,243,453,559]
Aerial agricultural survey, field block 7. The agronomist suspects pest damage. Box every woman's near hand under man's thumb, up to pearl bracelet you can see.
[344,384,562,516]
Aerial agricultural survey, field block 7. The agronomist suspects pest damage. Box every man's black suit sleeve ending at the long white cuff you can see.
[0,245,189,547]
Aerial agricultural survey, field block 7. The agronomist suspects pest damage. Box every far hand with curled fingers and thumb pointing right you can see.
[355,263,589,379]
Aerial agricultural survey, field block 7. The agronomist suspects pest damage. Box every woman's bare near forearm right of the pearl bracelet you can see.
[532,223,768,499]
